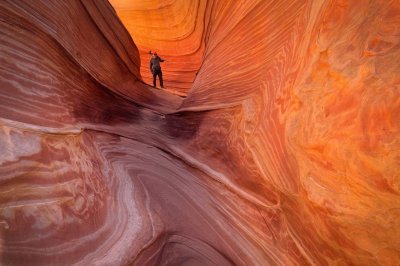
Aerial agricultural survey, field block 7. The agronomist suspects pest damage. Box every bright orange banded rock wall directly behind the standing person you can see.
[110,0,206,96]
